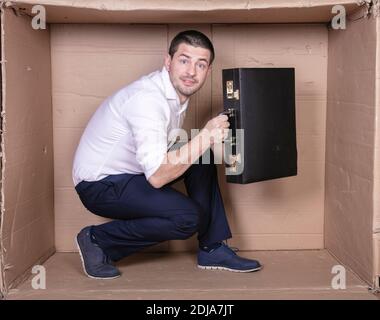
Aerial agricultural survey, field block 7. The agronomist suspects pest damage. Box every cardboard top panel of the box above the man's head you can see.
[12,0,358,23]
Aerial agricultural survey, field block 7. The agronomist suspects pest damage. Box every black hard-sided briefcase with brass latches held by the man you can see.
[223,68,297,184]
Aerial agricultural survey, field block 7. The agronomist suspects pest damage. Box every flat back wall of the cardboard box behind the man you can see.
[51,24,328,251]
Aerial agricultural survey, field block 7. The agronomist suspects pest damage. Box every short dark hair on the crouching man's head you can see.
[169,30,215,65]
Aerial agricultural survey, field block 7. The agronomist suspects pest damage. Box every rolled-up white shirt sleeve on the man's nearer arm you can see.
[124,92,170,179]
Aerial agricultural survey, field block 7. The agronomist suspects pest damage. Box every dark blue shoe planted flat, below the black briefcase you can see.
[198,243,261,272]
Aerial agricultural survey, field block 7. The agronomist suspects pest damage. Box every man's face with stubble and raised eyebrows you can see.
[165,43,211,103]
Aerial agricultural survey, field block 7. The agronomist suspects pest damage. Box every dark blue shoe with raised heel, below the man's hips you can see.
[75,227,120,279]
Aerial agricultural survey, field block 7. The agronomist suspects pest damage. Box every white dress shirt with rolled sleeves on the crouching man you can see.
[72,67,189,185]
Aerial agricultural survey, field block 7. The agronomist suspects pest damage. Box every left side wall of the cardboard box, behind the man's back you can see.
[1,10,54,287]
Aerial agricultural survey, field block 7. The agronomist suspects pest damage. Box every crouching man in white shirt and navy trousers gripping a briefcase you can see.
[73,30,261,279]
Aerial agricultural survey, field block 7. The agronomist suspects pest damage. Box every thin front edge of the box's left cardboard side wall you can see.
[0,1,6,299]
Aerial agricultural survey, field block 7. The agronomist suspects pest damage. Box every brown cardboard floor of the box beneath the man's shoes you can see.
[7,250,380,300]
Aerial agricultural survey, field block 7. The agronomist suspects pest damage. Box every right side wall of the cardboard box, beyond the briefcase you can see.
[325,9,376,283]
